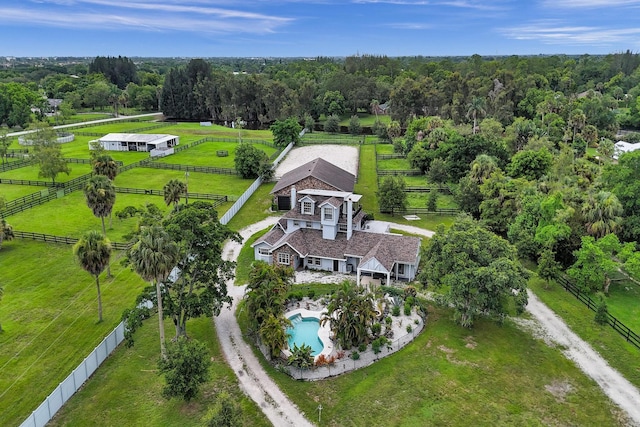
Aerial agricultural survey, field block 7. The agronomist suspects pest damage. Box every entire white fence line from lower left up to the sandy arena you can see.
[20,139,293,427]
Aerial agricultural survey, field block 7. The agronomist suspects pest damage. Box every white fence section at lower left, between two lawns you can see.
[20,322,124,427]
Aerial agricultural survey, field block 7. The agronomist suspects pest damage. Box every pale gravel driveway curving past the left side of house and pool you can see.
[215,217,313,427]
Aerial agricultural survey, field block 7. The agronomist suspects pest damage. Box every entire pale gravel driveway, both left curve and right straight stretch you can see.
[215,217,640,427]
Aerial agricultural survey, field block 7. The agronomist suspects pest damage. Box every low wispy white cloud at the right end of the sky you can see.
[499,21,640,46]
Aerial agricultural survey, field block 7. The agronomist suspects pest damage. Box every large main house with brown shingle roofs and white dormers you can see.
[252,159,420,284]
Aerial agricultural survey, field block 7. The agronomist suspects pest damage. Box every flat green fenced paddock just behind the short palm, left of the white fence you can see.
[114,167,254,197]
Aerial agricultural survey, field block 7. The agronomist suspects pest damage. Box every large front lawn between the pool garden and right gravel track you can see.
[240,307,624,426]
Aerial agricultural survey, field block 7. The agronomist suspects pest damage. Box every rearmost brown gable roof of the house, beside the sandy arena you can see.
[271,157,356,193]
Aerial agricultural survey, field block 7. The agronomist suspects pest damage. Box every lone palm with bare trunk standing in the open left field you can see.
[73,230,111,322]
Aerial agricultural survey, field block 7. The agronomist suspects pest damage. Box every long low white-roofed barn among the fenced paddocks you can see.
[89,133,180,156]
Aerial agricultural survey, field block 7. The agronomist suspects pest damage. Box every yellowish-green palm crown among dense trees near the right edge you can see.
[582,191,623,239]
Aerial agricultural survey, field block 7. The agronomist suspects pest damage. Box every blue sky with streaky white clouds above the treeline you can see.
[0,0,640,57]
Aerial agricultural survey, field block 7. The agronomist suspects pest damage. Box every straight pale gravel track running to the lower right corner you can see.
[527,291,640,426]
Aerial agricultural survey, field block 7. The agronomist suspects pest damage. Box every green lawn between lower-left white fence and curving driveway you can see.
[48,317,271,427]
